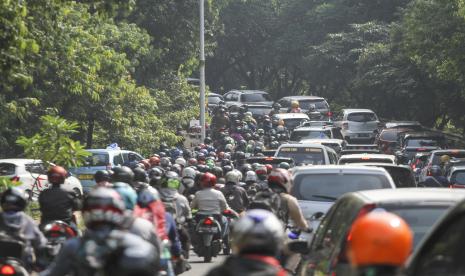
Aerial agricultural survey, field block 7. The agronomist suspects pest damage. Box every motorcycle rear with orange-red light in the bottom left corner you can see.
[0,237,29,276]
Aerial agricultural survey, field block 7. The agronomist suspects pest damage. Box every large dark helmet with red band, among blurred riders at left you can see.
[82,187,125,229]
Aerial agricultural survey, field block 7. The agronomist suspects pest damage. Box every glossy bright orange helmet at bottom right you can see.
[348,211,413,267]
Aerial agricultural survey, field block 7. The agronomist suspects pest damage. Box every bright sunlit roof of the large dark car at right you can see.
[352,188,465,203]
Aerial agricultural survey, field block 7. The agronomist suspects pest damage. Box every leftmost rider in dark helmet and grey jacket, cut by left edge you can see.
[0,187,47,270]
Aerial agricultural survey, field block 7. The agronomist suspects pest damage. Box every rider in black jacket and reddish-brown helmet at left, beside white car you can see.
[39,166,81,231]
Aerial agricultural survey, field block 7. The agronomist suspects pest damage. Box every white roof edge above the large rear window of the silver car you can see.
[293,165,389,175]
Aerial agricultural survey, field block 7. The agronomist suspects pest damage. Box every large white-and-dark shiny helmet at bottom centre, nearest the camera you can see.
[231,209,284,256]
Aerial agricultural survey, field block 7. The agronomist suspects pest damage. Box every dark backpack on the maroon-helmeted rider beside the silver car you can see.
[249,188,288,223]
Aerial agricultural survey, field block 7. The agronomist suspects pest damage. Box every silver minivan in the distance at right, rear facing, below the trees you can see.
[334,109,381,143]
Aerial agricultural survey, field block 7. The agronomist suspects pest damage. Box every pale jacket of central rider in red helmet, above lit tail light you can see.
[191,188,229,215]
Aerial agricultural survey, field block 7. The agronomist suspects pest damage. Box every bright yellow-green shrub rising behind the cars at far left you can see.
[17,115,89,168]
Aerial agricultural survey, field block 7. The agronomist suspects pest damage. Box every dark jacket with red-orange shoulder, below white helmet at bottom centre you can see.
[207,255,288,276]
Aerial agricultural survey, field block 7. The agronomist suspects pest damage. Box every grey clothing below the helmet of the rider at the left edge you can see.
[0,212,47,268]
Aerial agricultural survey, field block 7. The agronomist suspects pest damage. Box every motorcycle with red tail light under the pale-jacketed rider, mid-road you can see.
[191,215,222,263]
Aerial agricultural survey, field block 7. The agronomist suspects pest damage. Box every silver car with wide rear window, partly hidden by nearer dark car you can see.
[291,165,396,229]
